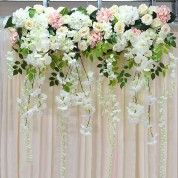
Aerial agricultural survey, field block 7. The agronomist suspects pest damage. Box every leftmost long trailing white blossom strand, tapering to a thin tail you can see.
[17,69,47,161]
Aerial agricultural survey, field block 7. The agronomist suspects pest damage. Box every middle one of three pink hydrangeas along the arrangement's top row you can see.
[96,8,114,23]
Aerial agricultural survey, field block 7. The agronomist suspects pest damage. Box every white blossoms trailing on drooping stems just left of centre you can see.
[56,64,95,135]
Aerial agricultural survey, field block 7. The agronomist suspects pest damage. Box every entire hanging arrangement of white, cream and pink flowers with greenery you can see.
[4,4,176,177]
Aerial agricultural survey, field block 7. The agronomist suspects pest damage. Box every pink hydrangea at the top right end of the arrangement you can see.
[156,5,171,24]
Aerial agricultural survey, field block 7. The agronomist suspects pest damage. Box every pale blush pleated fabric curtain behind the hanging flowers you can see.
[0,18,178,178]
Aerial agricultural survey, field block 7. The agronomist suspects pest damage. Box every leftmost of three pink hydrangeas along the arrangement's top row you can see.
[48,11,64,29]
